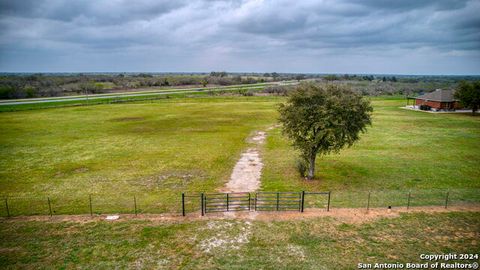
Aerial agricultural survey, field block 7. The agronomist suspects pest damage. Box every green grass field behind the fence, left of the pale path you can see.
[0,97,277,215]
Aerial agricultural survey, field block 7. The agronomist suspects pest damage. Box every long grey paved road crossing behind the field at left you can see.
[0,82,296,106]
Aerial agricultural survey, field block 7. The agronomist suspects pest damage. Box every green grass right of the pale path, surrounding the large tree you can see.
[262,98,480,207]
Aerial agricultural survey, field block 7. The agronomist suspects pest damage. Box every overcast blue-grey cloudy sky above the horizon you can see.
[0,0,480,74]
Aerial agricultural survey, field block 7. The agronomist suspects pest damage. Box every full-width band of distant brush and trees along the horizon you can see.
[0,71,480,99]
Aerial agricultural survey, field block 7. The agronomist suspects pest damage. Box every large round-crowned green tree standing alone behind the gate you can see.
[279,83,373,179]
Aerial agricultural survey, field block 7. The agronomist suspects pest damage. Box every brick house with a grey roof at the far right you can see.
[415,89,462,111]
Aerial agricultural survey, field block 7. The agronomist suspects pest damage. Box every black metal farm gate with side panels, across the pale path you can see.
[182,191,331,216]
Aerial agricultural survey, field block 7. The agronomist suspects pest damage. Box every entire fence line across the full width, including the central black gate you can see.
[0,189,480,217]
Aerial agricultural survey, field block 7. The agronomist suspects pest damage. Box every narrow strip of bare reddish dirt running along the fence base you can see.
[0,204,480,223]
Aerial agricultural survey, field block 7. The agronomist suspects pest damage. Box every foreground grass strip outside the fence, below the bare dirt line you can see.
[0,212,480,269]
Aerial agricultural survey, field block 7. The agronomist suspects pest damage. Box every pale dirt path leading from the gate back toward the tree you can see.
[222,131,267,192]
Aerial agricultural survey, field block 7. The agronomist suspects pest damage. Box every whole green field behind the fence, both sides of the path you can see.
[0,97,480,215]
